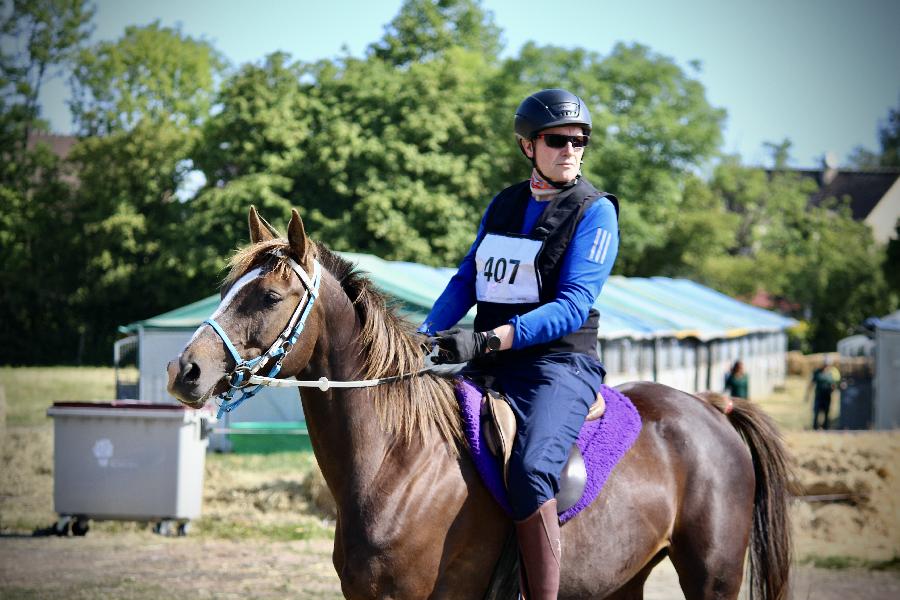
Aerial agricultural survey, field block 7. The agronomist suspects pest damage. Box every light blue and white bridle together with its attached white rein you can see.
[204,256,431,419]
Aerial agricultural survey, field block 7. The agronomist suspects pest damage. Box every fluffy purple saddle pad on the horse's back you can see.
[456,378,641,523]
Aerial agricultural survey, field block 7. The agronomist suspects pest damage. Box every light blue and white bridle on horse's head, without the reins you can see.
[204,257,322,419]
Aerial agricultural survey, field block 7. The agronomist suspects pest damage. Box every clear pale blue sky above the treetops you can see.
[35,0,900,166]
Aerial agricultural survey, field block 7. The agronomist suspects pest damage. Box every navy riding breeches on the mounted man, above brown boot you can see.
[489,352,606,520]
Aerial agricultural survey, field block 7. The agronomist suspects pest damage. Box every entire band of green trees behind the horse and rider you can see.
[0,0,888,363]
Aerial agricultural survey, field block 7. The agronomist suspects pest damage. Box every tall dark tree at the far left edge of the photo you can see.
[0,0,93,363]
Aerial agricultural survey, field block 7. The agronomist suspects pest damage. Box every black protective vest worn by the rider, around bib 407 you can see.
[474,177,619,360]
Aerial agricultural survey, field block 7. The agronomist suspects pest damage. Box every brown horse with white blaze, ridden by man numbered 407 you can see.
[169,209,790,599]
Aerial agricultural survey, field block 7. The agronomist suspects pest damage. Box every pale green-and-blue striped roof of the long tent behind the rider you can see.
[119,252,796,340]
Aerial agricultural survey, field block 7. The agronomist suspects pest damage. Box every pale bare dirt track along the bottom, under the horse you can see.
[0,532,900,600]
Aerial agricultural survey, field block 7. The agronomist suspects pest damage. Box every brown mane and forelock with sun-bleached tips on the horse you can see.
[225,239,463,452]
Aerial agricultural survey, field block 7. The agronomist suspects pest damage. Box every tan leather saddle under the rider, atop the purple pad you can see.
[480,388,606,514]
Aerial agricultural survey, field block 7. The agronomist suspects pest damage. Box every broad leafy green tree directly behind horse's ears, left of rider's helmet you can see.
[194,48,502,264]
